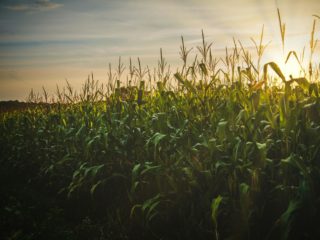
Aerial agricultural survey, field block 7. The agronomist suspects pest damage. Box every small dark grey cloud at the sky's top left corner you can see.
[6,0,63,12]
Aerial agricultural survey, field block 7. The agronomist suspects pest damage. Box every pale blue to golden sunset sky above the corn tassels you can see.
[0,0,320,101]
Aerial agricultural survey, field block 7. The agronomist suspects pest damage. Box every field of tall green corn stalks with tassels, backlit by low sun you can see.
[0,14,320,240]
